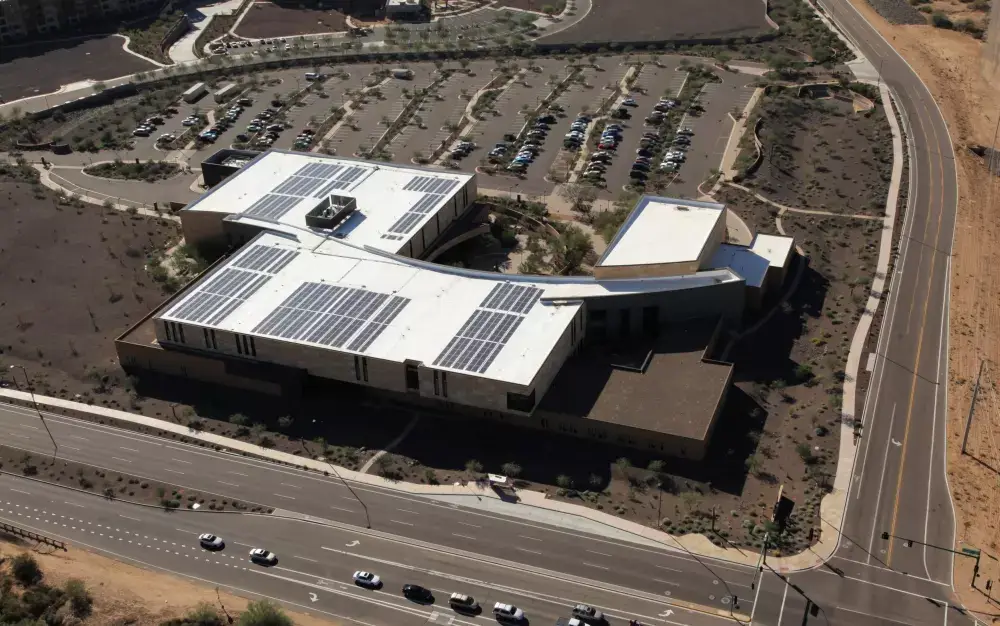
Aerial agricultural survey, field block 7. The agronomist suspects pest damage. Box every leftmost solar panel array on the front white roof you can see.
[167,267,271,326]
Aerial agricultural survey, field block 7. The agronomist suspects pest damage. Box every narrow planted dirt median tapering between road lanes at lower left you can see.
[0,446,273,513]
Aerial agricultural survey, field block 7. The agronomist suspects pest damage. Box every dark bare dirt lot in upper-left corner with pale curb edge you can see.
[0,35,155,102]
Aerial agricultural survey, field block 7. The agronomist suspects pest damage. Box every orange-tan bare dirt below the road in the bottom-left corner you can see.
[0,536,334,626]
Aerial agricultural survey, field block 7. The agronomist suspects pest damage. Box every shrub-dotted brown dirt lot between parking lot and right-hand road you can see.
[744,90,892,215]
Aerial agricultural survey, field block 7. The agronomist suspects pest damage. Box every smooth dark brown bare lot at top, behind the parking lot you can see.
[541,0,771,43]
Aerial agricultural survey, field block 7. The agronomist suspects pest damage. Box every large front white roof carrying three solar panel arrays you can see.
[159,232,581,386]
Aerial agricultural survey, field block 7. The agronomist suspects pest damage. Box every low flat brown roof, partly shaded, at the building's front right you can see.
[538,319,733,441]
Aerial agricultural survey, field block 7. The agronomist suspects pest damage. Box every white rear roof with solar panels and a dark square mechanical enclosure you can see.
[185,150,474,253]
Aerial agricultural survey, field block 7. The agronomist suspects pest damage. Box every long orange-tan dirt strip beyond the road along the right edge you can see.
[852,0,1000,613]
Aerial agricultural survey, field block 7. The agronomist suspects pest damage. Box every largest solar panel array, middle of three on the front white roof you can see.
[253,283,410,352]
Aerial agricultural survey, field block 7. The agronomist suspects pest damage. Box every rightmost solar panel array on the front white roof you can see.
[434,283,542,374]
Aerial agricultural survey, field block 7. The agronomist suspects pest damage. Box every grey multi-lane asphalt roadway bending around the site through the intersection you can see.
[0,0,972,626]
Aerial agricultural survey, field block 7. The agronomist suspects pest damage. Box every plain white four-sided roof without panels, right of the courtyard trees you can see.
[597,196,726,267]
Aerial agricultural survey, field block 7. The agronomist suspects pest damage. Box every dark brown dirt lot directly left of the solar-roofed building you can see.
[0,171,176,381]
